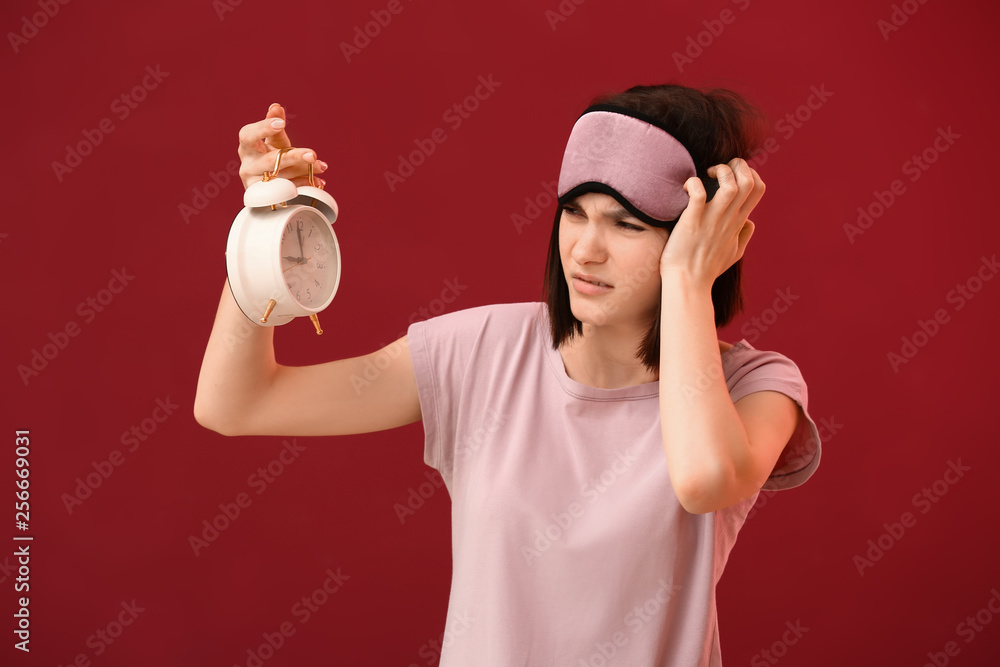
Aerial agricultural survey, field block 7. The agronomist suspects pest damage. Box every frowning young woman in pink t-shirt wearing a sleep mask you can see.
[195,85,820,667]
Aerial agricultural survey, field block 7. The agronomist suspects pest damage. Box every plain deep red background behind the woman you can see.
[0,0,1000,667]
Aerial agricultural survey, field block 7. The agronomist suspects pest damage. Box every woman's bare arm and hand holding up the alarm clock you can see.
[194,105,420,436]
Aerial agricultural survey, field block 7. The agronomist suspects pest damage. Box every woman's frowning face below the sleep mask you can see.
[559,192,668,328]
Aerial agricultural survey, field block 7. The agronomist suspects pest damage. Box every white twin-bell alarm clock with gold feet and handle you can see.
[226,148,340,334]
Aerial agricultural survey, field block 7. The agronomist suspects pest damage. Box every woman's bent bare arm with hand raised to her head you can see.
[659,159,799,514]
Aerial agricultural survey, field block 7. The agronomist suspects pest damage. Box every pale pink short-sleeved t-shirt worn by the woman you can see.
[408,303,820,667]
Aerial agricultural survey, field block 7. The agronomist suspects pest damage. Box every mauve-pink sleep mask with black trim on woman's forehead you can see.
[557,104,718,228]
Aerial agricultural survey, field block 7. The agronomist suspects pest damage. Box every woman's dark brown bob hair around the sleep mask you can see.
[542,84,767,371]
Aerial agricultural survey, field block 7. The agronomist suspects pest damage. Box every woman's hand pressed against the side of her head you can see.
[660,158,764,289]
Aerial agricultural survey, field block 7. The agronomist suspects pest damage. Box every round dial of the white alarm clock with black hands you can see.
[281,210,338,308]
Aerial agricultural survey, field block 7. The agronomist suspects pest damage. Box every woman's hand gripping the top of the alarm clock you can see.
[239,103,327,188]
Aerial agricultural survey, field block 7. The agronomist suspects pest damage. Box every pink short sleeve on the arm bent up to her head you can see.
[727,344,822,491]
